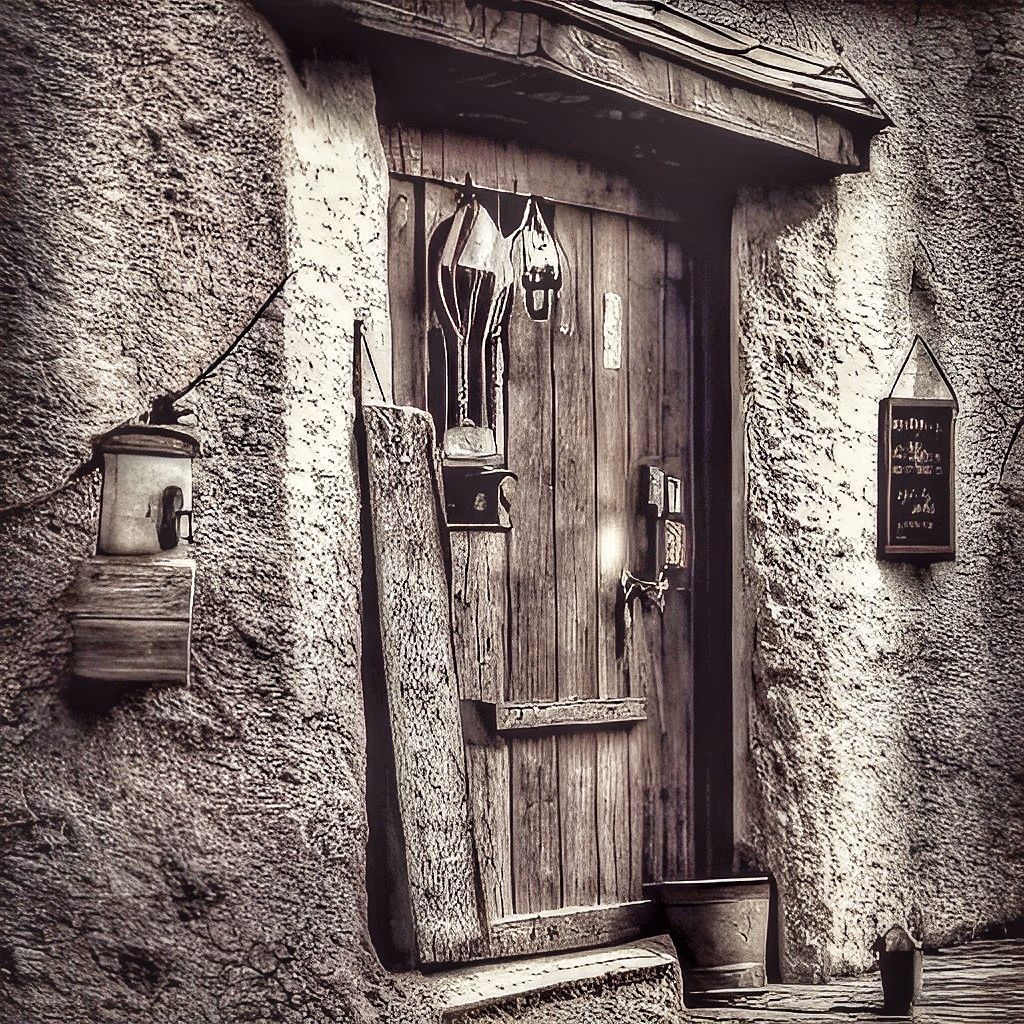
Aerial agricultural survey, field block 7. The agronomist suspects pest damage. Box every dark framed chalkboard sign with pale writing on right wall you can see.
[879,398,956,562]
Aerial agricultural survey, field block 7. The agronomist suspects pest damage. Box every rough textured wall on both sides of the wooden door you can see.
[0,0,1024,1024]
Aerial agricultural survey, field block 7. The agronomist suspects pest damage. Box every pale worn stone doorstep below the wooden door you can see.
[431,935,683,1024]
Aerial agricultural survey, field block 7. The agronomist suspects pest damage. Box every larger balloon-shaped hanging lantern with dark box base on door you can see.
[430,175,515,529]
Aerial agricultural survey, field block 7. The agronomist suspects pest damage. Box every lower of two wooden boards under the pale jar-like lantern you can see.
[71,614,190,686]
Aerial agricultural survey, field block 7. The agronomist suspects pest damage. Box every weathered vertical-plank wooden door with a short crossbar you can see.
[383,126,697,956]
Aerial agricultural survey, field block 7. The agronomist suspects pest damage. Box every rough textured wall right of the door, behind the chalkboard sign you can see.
[687,0,1024,977]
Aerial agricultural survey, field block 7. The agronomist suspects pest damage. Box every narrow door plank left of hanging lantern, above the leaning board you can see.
[387,178,426,409]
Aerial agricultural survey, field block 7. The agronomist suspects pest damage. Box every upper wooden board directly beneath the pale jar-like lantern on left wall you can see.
[68,555,196,622]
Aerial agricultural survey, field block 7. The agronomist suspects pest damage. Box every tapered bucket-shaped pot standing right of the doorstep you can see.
[644,878,769,994]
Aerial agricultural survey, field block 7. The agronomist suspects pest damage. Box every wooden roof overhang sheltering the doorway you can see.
[257,0,890,188]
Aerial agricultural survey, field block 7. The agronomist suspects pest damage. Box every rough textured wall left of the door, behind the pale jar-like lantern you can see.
[0,0,434,1024]
